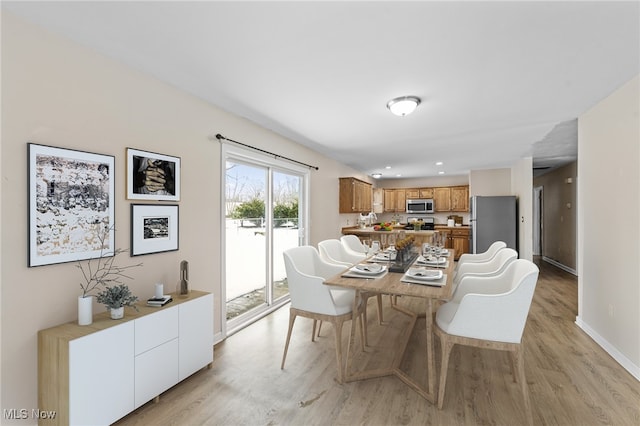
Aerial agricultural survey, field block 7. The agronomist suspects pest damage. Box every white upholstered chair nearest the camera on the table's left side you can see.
[280,246,366,383]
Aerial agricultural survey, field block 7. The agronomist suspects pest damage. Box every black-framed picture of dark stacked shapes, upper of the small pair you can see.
[127,148,180,201]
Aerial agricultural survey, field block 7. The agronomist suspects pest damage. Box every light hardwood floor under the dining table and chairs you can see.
[117,263,640,426]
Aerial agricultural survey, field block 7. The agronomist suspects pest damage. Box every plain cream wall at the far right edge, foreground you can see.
[576,76,640,380]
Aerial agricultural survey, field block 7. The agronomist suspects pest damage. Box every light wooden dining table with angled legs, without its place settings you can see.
[325,249,455,404]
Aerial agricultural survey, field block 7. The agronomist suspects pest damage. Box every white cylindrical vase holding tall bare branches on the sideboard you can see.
[76,223,142,325]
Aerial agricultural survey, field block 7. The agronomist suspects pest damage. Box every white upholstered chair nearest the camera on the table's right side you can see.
[434,259,538,425]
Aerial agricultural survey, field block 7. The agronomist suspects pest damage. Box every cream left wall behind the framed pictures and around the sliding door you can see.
[0,11,364,425]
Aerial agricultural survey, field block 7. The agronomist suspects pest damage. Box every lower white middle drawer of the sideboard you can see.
[135,338,178,408]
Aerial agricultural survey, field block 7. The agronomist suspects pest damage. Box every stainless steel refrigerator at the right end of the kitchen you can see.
[469,195,518,253]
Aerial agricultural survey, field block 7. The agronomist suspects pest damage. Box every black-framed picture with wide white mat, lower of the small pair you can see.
[131,204,179,256]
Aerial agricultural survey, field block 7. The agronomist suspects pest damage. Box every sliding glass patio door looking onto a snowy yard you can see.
[222,146,308,335]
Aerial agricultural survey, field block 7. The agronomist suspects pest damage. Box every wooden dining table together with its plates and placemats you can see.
[325,249,455,404]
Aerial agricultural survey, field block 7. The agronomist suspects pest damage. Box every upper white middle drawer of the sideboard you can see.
[135,306,178,355]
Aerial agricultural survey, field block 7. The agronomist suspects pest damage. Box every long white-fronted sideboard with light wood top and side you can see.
[38,291,213,425]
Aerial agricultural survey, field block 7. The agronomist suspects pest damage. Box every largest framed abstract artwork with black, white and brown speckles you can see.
[27,143,115,267]
